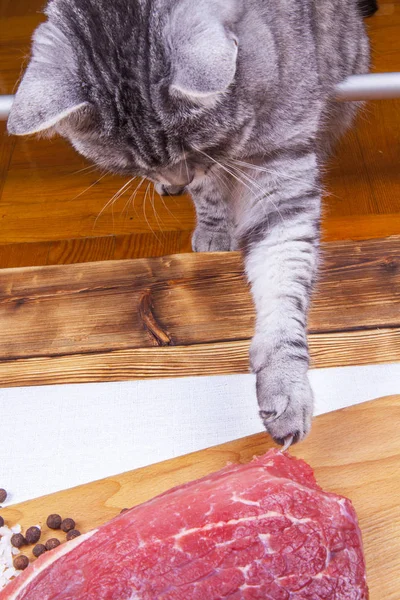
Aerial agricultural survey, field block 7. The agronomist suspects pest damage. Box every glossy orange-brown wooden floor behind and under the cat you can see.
[0,0,400,268]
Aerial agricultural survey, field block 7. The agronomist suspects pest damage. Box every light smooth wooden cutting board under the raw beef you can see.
[1,395,400,600]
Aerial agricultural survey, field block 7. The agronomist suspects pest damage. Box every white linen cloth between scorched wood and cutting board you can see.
[0,363,400,504]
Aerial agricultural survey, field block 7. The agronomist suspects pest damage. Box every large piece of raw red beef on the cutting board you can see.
[0,450,368,600]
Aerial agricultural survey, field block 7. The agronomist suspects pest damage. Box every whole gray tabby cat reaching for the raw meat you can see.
[8,0,369,443]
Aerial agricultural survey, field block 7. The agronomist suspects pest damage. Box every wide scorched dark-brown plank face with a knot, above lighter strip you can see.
[0,237,400,360]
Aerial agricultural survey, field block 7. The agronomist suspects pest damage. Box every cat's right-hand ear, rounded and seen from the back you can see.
[170,2,238,104]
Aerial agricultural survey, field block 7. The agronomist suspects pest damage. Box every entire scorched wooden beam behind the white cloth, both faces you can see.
[0,237,400,385]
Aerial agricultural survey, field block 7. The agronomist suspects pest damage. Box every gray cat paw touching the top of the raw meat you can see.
[257,361,314,445]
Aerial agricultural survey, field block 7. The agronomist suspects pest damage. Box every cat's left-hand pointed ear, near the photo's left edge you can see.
[7,23,87,135]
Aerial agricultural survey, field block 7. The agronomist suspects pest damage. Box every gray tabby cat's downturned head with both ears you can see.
[8,0,253,193]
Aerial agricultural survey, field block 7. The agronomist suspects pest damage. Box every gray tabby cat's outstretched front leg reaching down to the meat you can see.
[238,150,320,444]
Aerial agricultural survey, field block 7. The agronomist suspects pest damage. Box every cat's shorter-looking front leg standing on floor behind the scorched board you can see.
[189,173,235,252]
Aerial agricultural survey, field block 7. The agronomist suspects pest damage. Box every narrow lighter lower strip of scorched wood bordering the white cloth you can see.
[0,328,400,387]
